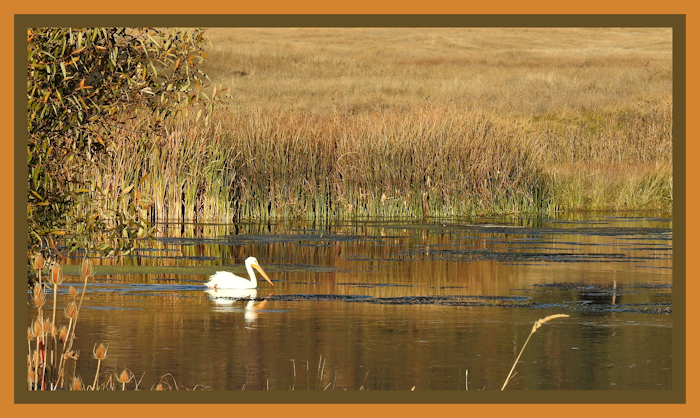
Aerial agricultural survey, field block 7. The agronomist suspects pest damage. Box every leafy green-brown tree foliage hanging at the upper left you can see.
[27,28,216,253]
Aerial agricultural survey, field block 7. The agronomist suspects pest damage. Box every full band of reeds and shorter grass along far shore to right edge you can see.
[88,99,673,221]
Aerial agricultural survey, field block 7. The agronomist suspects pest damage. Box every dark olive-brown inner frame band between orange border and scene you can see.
[6,15,687,412]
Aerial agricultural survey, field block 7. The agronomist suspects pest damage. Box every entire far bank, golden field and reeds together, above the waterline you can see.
[86,29,673,221]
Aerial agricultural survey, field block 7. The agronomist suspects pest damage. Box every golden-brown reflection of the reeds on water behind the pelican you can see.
[63,218,672,287]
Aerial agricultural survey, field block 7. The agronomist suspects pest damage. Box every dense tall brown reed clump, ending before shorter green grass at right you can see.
[90,108,547,220]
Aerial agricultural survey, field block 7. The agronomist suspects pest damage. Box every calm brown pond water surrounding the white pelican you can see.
[29,214,673,390]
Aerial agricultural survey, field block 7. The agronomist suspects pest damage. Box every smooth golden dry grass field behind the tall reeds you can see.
[200,28,672,115]
